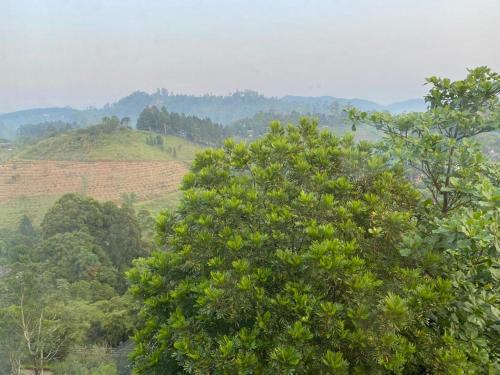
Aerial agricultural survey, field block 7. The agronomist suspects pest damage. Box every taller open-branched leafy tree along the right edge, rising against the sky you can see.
[350,67,500,374]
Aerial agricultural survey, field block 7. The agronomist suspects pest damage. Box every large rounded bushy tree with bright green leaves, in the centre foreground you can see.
[128,119,463,374]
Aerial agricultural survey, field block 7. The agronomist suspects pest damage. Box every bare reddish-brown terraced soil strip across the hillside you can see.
[0,160,188,202]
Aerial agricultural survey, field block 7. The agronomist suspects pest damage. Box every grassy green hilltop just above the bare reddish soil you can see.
[13,128,201,161]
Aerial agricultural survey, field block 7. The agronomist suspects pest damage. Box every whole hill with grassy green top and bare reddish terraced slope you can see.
[0,126,202,228]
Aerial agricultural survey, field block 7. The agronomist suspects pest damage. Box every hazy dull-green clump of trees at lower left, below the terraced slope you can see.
[0,194,145,374]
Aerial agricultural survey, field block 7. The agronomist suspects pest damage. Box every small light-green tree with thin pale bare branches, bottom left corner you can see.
[0,263,94,369]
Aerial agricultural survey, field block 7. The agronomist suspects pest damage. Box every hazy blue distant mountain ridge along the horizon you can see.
[0,89,425,139]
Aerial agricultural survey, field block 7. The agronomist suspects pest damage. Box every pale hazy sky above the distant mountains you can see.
[0,0,500,112]
